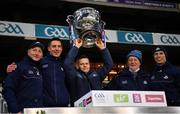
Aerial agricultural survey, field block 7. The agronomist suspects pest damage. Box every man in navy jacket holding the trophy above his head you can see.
[64,39,113,106]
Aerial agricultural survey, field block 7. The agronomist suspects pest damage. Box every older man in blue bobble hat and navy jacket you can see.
[104,50,150,91]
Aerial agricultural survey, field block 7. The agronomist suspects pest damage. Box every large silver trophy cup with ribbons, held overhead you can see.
[67,7,105,48]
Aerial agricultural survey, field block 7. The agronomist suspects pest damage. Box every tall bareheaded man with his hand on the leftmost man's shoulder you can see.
[7,38,69,107]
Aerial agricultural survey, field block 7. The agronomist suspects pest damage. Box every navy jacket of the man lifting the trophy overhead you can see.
[64,47,113,105]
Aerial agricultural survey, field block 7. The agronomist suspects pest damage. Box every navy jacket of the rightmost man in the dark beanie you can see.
[151,62,180,105]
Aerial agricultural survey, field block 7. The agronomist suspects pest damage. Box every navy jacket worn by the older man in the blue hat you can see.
[104,68,151,91]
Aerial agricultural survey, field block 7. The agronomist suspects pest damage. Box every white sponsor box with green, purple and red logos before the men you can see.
[74,90,167,107]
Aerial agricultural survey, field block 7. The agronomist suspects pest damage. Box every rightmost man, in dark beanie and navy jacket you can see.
[151,47,180,106]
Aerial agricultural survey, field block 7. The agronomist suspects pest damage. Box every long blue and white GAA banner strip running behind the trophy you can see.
[0,21,180,46]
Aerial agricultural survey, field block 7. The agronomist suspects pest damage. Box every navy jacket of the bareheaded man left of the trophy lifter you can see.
[42,54,69,107]
